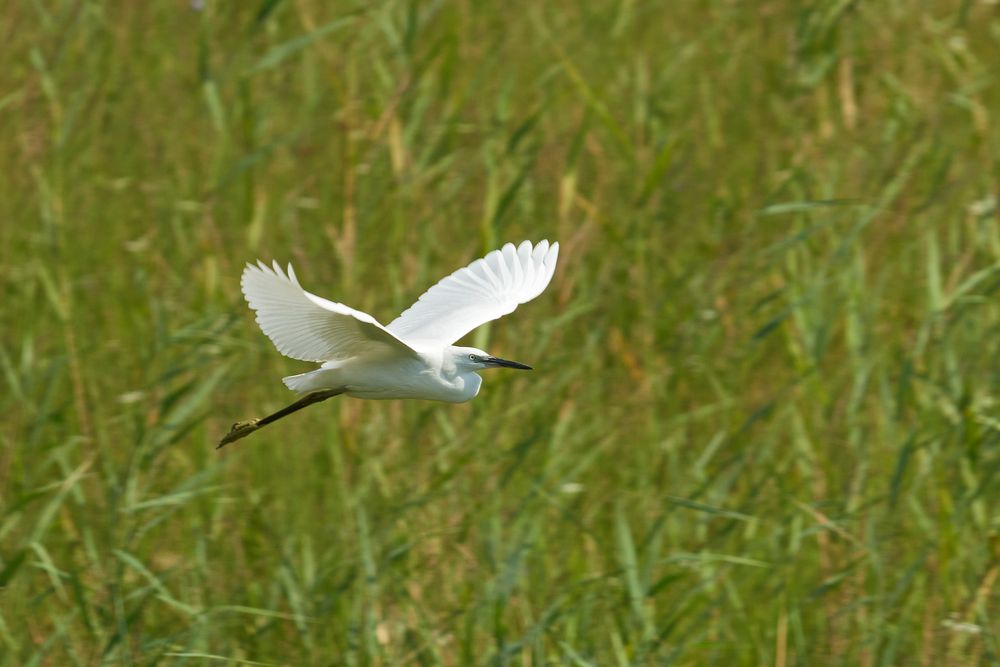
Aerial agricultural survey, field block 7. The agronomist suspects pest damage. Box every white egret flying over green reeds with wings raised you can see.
[219,241,559,447]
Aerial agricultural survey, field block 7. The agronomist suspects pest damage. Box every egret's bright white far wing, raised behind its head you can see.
[386,241,559,345]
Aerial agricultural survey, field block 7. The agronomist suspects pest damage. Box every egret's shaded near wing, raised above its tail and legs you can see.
[240,261,416,361]
